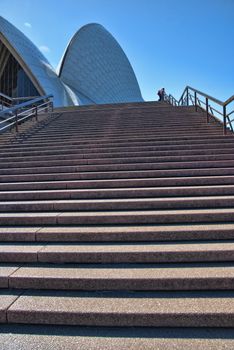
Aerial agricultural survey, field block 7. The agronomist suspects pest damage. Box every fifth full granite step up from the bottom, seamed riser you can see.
[0,208,234,226]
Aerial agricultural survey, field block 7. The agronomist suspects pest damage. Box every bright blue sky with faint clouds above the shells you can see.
[0,0,234,101]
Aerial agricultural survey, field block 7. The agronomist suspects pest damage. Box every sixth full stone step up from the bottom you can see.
[0,196,234,215]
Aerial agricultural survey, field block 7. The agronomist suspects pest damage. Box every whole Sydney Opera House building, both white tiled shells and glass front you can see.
[0,17,143,106]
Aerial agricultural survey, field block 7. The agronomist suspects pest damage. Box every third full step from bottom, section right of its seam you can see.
[36,241,234,263]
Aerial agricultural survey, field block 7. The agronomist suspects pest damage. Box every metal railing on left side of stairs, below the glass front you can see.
[0,95,53,133]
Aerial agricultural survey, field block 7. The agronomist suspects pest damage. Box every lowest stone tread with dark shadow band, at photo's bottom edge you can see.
[0,324,234,350]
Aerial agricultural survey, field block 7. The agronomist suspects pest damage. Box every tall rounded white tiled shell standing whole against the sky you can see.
[59,23,143,103]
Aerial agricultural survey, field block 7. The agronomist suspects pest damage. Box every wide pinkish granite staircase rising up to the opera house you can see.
[0,103,234,349]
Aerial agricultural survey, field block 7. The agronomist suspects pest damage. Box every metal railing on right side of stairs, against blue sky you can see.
[165,86,234,135]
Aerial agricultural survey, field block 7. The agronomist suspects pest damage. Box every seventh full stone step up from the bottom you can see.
[0,183,234,201]
